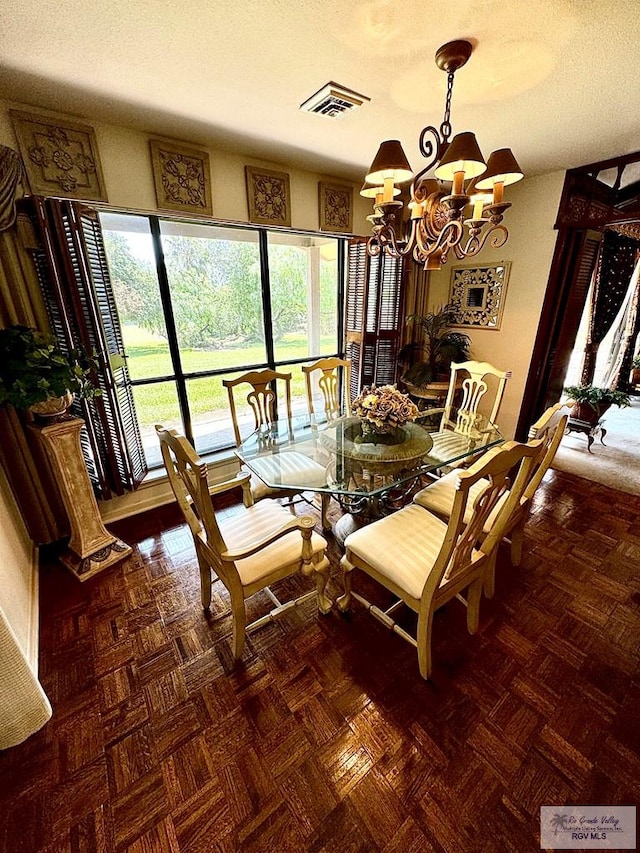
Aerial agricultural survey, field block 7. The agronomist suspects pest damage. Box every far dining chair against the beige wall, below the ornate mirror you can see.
[427,361,511,460]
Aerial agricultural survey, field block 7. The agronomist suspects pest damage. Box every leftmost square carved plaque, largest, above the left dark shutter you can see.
[9,110,108,201]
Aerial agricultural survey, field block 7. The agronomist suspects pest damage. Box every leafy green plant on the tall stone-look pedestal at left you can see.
[0,326,102,409]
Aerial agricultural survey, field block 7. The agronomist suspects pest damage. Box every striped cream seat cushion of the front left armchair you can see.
[218,499,327,586]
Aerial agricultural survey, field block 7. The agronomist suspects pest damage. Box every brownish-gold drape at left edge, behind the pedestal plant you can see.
[0,214,68,544]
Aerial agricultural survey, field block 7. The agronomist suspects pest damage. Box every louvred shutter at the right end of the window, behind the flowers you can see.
[346,239,404,393]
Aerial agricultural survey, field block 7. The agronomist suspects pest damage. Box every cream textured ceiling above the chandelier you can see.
[0,0,640,181]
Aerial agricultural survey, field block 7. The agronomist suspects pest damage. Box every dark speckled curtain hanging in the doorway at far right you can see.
[581,230,638,385]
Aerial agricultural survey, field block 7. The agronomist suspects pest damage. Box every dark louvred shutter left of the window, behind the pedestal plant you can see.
[23,198,147,500]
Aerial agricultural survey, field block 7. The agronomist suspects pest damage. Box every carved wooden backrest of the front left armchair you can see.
[156,424,229,568]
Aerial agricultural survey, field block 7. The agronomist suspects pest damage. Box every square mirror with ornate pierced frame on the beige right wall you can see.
[449,262,511,330]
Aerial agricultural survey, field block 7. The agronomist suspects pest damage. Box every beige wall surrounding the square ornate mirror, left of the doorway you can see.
[428,172,565,437]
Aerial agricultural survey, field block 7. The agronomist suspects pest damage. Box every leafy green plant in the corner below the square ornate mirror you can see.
[398,305,471,388]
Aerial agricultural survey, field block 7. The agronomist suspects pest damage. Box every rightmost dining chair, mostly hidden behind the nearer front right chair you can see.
[413,403,570,598]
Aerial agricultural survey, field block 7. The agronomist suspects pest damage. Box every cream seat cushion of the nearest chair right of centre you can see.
[344,504,447,598]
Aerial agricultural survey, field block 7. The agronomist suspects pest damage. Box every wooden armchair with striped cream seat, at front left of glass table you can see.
[156,424,332,659]
